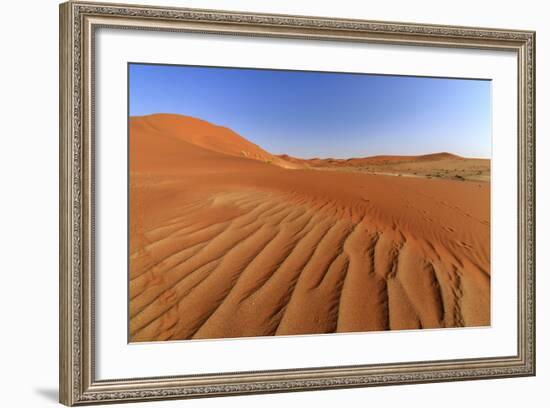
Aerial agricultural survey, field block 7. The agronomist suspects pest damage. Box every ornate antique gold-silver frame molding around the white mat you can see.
[59,1,535,406]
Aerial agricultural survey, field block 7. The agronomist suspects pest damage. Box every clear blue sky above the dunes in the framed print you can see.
[129,64,491,158]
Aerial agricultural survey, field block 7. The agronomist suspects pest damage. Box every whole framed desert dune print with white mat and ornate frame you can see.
[60,2,535,405]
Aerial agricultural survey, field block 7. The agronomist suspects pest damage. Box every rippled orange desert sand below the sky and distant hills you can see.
[129,115,491,342]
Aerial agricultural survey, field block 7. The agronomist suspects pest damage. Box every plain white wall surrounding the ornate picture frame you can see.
[0,0,550,408]
